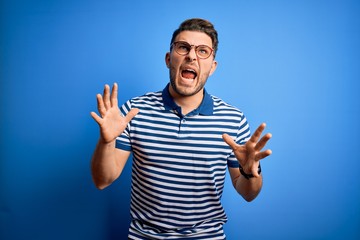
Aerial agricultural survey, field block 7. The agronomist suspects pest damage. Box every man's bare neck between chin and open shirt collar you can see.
[169,86,204,115]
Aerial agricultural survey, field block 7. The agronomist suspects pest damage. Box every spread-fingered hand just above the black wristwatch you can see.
[223,123,272,177]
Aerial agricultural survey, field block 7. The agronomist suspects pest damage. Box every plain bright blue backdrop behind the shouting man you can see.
[0,0,360,240]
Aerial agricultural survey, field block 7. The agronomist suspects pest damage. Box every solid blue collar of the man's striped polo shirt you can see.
[162,83,214,115]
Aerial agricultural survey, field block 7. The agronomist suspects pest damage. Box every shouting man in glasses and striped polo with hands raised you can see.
[91,19,271,239]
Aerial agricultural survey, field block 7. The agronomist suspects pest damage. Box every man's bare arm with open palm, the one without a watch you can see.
[91,83,139,189]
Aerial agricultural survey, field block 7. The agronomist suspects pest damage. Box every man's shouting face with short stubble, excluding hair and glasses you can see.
[165,31,217,97]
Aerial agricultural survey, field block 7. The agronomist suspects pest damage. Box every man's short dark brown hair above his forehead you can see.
[170,18,219,56]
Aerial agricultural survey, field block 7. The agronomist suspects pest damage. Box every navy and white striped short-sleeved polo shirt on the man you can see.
[116,85,250,240]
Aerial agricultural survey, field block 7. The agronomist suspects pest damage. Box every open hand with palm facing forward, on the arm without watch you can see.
[90,83,139,143]
